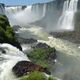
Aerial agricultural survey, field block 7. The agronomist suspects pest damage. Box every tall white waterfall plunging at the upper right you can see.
[58,0,78,30]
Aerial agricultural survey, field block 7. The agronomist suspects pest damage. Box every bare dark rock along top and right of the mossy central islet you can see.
[32,43,57,60]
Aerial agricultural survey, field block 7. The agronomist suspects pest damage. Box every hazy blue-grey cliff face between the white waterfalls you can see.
[32,0,64,30]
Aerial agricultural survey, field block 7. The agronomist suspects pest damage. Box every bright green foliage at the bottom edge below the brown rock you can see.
[20,71,56,80]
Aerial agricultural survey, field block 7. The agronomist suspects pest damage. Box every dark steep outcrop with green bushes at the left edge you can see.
[0,15,22,50]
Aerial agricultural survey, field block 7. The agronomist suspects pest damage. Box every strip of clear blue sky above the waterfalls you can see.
[0,0,52,5]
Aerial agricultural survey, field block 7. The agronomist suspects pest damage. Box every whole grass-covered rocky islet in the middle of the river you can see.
[27,43,57,68]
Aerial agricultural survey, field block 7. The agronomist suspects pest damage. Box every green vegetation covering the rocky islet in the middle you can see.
[27,48,54,68]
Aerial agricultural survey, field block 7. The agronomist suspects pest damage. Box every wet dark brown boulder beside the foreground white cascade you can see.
[12,61,51,77]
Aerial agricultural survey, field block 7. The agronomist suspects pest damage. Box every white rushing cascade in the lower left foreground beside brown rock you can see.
[0,43,30,80]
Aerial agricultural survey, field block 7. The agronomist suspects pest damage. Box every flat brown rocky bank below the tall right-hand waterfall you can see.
[50,31,80,44]
